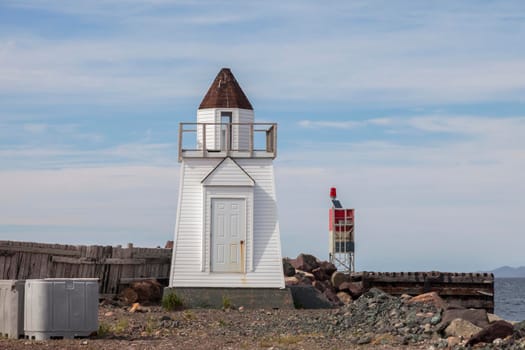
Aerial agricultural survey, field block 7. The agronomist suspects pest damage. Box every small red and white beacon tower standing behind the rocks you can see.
[328,187,355,273]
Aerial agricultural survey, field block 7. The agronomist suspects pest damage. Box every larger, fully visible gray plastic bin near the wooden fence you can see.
[24,278,98,340]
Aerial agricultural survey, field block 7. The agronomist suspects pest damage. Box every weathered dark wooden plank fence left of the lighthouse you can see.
[0,241,172,295]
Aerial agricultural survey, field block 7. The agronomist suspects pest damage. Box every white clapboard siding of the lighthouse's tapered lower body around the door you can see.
[170,159,284,288]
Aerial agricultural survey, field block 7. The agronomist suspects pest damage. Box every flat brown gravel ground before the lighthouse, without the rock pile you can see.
[0,306,427,350]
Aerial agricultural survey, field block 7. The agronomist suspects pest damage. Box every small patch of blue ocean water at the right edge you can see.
[494,278,525,321]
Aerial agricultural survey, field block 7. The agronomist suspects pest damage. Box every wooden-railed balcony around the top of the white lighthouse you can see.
[179,123,277,162]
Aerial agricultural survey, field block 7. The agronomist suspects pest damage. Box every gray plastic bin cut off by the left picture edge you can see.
[0,280,25,339]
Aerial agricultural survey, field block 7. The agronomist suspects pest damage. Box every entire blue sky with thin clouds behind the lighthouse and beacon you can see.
[0,0,525,271]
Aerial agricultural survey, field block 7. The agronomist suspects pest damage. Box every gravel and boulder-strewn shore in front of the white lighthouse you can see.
[0,254,525,350]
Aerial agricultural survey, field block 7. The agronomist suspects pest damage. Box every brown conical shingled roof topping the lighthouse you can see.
[199,68,253,110]
